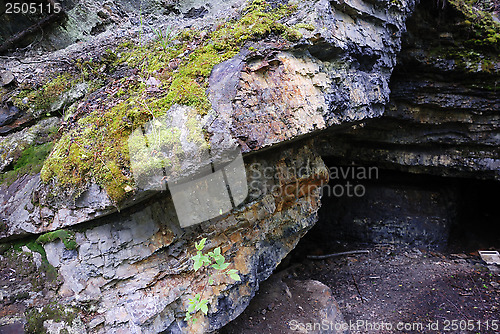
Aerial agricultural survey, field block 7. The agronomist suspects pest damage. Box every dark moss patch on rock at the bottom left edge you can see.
[24,302,77,334]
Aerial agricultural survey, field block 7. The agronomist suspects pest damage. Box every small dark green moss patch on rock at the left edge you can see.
[0,143,54,185]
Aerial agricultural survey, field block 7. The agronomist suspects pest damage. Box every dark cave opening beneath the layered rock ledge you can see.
[290,158,500,262]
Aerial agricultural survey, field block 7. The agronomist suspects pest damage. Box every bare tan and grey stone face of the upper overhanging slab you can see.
[209,1,414,152]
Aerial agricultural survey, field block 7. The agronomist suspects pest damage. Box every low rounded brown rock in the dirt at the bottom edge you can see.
[218,269,349,334]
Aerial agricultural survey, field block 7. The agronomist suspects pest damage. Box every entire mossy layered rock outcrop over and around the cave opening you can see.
[0,0,499,333]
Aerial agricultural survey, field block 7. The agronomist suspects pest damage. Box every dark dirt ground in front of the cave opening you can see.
[224,245,500,334]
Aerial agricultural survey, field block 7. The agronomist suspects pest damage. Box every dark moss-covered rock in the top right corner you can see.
[402,0,500,87]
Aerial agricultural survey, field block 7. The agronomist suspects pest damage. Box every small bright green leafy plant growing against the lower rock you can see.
[184,238,241,323]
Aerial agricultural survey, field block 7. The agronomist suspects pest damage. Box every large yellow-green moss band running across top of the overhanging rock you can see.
[41,0,301,205]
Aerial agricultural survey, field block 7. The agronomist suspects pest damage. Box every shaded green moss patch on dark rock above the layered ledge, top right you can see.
[417,0,500,80]
